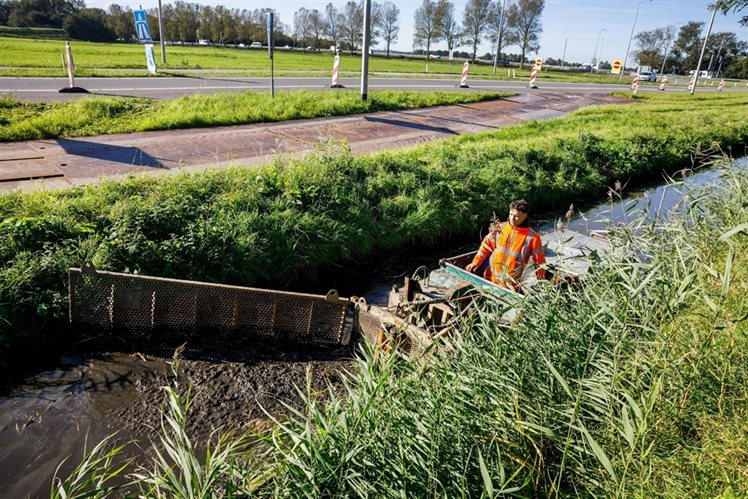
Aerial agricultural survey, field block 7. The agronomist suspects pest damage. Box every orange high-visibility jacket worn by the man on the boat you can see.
[473,223,545,289]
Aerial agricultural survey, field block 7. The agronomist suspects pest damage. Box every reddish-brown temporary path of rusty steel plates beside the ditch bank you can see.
[0,92,623,192]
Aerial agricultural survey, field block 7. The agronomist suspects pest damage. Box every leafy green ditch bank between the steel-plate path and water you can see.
[0,94,748,382]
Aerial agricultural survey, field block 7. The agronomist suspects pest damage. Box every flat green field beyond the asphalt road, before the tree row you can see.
[0,34,687,85]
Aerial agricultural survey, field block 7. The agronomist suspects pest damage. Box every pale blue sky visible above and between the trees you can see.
[86,0,748,64]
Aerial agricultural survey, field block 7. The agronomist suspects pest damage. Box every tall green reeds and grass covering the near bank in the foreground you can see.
[55,162,748,498]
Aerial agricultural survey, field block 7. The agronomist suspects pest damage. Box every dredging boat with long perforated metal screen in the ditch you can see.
[69,229,610,355]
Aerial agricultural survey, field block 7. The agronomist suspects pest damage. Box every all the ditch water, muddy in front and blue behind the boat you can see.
[0,160,748,498]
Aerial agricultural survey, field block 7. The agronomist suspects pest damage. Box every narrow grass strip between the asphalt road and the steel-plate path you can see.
[0,90,511,142]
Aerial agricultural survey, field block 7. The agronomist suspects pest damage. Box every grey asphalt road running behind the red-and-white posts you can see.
[0,76,732,102]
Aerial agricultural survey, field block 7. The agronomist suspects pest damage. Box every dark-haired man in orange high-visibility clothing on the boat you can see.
[465,199,545,291]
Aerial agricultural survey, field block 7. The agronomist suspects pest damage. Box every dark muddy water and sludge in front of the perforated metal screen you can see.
[0,345,351,497]
